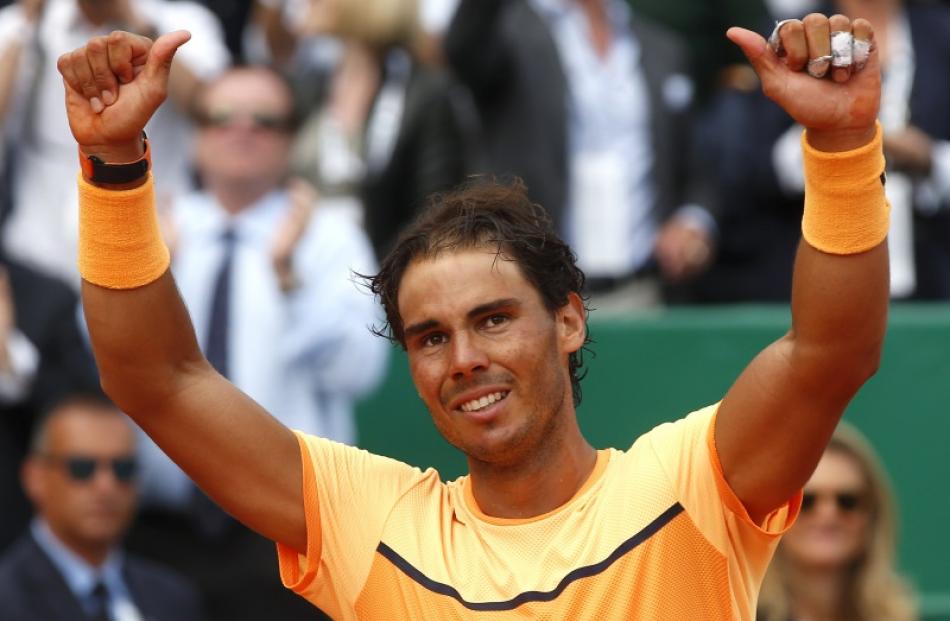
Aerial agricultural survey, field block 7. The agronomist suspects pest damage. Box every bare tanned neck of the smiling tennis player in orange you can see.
[469,416,597,519]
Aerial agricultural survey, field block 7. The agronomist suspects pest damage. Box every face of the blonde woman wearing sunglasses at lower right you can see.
[782,450,871,569]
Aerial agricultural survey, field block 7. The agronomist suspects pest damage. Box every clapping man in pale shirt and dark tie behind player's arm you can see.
[130,67,388,621]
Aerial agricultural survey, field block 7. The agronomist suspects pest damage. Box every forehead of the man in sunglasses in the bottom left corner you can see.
[47,407,135,455]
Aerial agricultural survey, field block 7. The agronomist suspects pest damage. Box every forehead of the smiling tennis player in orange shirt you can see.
[397,248,541,326]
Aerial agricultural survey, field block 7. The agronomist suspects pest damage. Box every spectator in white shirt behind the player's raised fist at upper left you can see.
[0,0,229,287]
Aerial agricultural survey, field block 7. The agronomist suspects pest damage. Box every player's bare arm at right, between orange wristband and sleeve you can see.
[716,242,888,518]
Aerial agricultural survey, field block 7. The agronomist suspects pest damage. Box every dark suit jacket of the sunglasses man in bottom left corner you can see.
[0,533,202,621]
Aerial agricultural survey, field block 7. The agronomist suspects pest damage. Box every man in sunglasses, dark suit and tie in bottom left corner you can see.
[0,397,201,621]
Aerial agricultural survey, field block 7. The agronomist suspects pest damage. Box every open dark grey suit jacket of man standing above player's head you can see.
[445,0,708,235]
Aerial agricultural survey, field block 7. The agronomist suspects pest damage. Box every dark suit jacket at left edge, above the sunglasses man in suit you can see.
[0,259,99,553]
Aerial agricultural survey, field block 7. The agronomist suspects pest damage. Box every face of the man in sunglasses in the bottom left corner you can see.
[24,406,136,551]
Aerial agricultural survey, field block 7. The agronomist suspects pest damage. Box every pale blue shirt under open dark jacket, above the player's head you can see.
[532,0,658,277]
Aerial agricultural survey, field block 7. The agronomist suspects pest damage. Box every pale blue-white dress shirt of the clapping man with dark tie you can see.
[141,191,390,506]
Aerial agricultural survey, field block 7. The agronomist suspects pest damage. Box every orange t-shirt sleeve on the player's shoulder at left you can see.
[277,432,436,614]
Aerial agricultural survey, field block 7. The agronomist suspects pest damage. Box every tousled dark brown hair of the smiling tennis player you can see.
[362,177,592,406]
